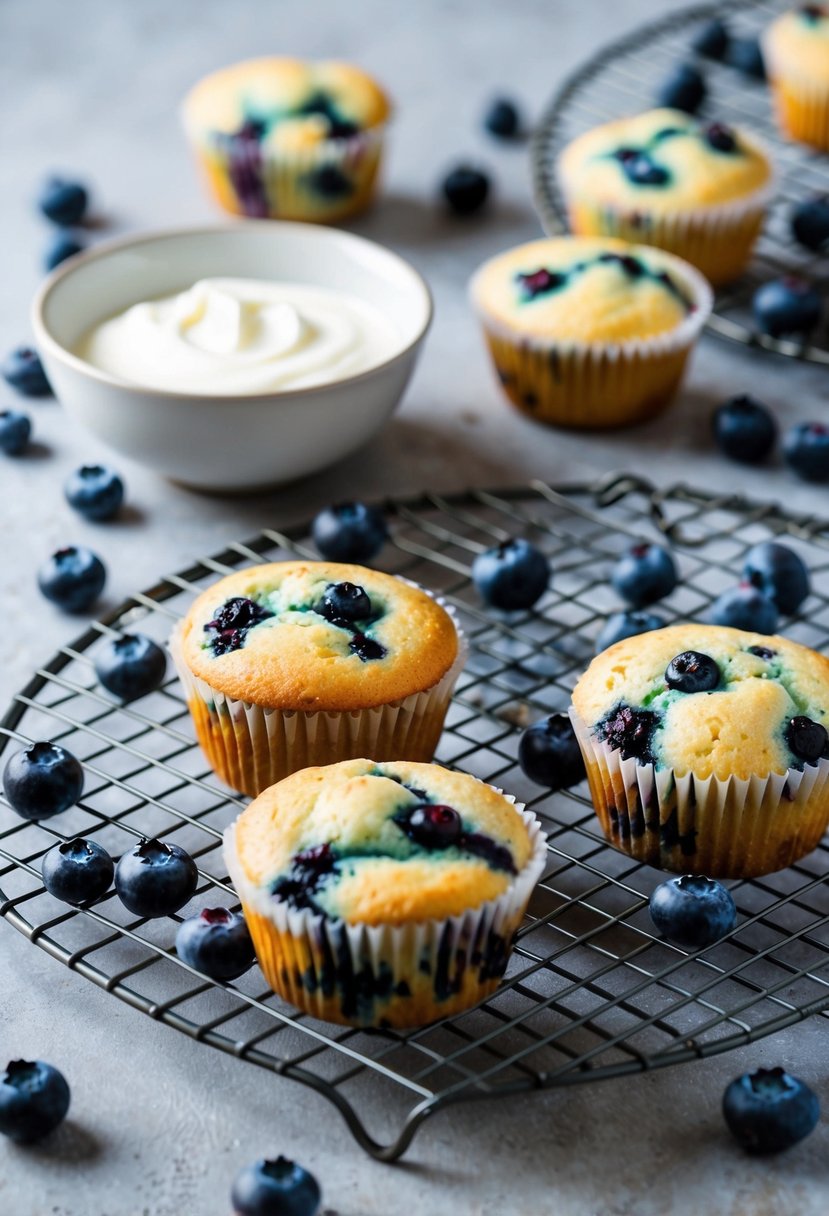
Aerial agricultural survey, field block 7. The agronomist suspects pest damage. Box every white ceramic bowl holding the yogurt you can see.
[33,220,432,491]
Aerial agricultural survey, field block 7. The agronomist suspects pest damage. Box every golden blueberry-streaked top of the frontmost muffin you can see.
[229,760,531,924]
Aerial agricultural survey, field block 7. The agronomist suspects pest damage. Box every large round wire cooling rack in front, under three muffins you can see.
[0,474,829,1160]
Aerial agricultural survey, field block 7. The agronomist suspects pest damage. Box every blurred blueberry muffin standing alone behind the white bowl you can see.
[184,57,389,223]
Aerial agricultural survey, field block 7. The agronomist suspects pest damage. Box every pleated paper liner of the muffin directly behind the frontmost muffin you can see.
[169,579,468,796]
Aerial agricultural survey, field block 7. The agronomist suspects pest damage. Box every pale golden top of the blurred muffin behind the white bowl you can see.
[184,57,389,151]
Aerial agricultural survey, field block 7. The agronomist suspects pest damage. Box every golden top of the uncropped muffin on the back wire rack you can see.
[559,109,771,214]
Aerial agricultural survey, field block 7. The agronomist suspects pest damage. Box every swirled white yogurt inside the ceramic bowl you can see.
[75,278,401,396]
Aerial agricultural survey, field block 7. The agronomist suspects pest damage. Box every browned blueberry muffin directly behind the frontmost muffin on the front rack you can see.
[170,562,464,794]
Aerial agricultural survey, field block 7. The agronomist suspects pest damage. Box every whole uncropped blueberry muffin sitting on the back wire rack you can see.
[558,109,772,286]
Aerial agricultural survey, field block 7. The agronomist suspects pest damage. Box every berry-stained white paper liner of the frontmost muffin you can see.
[224,787,547,1028]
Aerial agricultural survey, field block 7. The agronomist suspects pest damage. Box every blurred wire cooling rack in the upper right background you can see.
[531,0,829,364]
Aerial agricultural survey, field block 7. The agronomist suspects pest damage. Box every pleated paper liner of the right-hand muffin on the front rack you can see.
[570,708,829,878]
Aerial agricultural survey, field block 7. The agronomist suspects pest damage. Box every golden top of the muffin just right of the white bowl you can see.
[470,236,699,342]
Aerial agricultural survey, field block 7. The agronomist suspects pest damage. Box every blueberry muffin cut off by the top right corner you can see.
[763,4,829,152]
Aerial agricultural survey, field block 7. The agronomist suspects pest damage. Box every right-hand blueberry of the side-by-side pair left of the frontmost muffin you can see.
[115,840,198,917]
